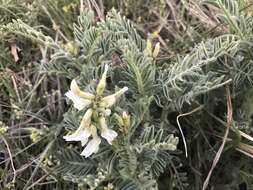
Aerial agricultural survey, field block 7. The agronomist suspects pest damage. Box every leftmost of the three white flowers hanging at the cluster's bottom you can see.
[63,109,92,142]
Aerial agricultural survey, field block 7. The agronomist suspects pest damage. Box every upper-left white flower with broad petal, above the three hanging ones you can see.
[65,80,95,110]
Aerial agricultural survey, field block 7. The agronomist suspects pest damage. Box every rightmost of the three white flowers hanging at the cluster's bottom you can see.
[99,117,118,144]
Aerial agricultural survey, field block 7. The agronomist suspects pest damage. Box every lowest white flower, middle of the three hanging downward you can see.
[81,125,101,158]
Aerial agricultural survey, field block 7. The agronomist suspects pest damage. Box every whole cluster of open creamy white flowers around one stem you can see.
[63,65,128,158]
